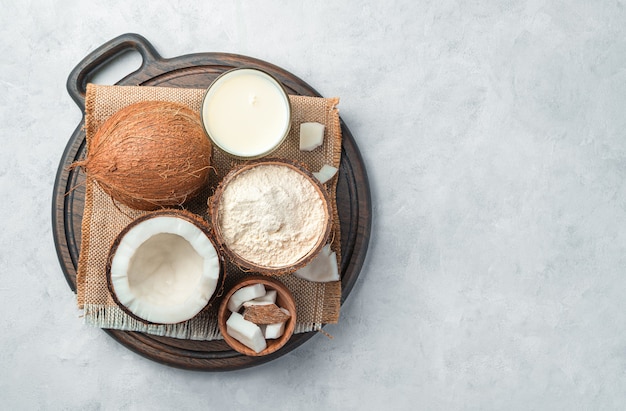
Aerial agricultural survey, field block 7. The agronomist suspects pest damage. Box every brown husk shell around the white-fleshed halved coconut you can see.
[106,209,226,325]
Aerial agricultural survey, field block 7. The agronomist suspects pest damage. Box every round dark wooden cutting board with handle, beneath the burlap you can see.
[52,34,371,371]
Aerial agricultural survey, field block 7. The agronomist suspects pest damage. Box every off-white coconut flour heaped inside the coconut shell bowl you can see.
[219,164,327,267]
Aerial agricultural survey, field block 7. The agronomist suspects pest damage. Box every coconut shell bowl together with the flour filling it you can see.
[208,159,332,276]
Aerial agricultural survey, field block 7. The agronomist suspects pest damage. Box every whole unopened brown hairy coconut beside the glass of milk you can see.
[73,101,212,210]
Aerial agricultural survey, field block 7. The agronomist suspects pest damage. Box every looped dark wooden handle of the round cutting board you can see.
[67,33,161,111]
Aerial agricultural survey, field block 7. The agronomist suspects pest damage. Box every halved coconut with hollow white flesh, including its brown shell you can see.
[107,210,224,324]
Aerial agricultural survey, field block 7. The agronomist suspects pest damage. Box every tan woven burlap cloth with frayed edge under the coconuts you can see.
[77,84,341,340]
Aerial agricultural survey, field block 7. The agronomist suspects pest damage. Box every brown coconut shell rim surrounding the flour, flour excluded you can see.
[207,158,332,276]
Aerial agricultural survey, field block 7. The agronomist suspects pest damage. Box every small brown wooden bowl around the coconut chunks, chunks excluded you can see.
[217,275,296,357]
